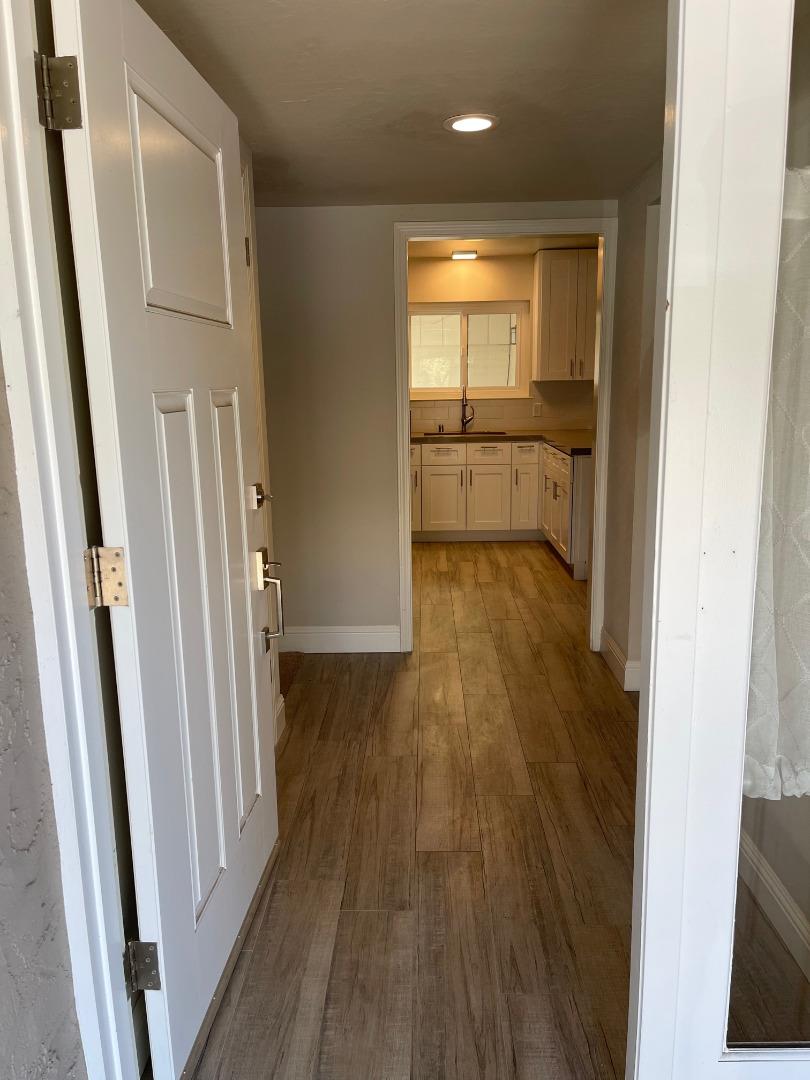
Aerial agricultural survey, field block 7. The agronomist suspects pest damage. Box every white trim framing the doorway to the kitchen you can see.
[394,211,619,652]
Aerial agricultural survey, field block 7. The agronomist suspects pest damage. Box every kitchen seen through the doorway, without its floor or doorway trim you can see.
[408,235,600,580]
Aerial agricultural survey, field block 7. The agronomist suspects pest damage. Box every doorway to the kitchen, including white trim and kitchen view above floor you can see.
[394,218,617,651]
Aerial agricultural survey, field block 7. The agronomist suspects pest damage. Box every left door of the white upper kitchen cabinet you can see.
[538,251,579,381]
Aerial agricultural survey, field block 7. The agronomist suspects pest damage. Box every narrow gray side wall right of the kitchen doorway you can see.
[605,161,661,660]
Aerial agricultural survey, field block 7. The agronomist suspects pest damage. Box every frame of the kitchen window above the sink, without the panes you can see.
[408,300,531,402]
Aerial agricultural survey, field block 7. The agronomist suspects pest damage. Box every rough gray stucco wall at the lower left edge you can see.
[0,356,86,1080]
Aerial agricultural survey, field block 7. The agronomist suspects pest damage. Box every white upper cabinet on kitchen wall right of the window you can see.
[531,248,597,382]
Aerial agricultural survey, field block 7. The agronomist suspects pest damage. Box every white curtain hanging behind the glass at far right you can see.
[741,168,810,799]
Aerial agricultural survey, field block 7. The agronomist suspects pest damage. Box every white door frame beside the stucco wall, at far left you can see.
[0,0,139,1080]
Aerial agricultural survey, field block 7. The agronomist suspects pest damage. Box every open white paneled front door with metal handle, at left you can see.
[54,0,278,1080]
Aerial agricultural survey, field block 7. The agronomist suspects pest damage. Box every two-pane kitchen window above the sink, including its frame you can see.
[408,300,530,400]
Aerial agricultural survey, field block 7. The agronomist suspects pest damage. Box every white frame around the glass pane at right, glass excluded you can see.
[626,0,810,1080]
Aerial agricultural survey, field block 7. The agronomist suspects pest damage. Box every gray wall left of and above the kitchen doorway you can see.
[256,202,616,626]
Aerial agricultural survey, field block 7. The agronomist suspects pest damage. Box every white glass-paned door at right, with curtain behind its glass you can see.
[627,0,810,1080]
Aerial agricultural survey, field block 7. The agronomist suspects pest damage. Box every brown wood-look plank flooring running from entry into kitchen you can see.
[197,542,807,1080]
